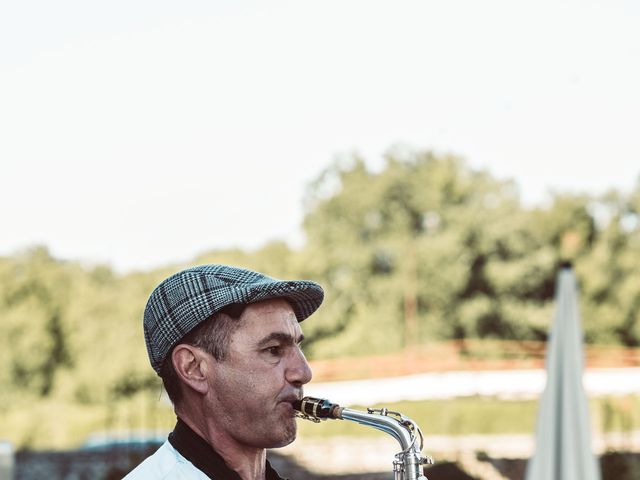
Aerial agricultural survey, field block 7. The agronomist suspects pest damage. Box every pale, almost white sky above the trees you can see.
[0,0,640,272]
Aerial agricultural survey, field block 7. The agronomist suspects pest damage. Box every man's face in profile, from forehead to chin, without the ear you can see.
[207,299,311,448]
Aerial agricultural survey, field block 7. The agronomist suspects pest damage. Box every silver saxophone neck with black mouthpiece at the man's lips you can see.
[293,397,433,480]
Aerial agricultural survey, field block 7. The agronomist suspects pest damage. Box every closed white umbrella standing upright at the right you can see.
[526,265,600,480]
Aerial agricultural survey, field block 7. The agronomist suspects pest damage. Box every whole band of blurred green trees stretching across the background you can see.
[0,149,640,446]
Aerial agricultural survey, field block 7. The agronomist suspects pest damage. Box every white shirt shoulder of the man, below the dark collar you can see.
[123,440,210,480]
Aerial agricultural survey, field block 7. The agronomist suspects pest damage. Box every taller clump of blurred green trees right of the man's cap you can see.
[304,150,640,350]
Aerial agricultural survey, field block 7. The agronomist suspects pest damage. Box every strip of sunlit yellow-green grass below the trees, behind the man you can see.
[0,394,640,450]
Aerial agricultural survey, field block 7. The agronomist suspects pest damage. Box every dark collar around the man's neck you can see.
[169,418,284,480]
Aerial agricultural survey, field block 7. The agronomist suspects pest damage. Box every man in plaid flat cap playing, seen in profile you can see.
[125,265,324,480]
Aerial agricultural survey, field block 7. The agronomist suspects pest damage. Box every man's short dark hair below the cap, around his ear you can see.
[160,303,247,405]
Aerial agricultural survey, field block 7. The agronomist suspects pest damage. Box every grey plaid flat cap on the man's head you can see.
[143,265,324,374]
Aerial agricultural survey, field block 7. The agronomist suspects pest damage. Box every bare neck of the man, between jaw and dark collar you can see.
[178,412,267,480]
